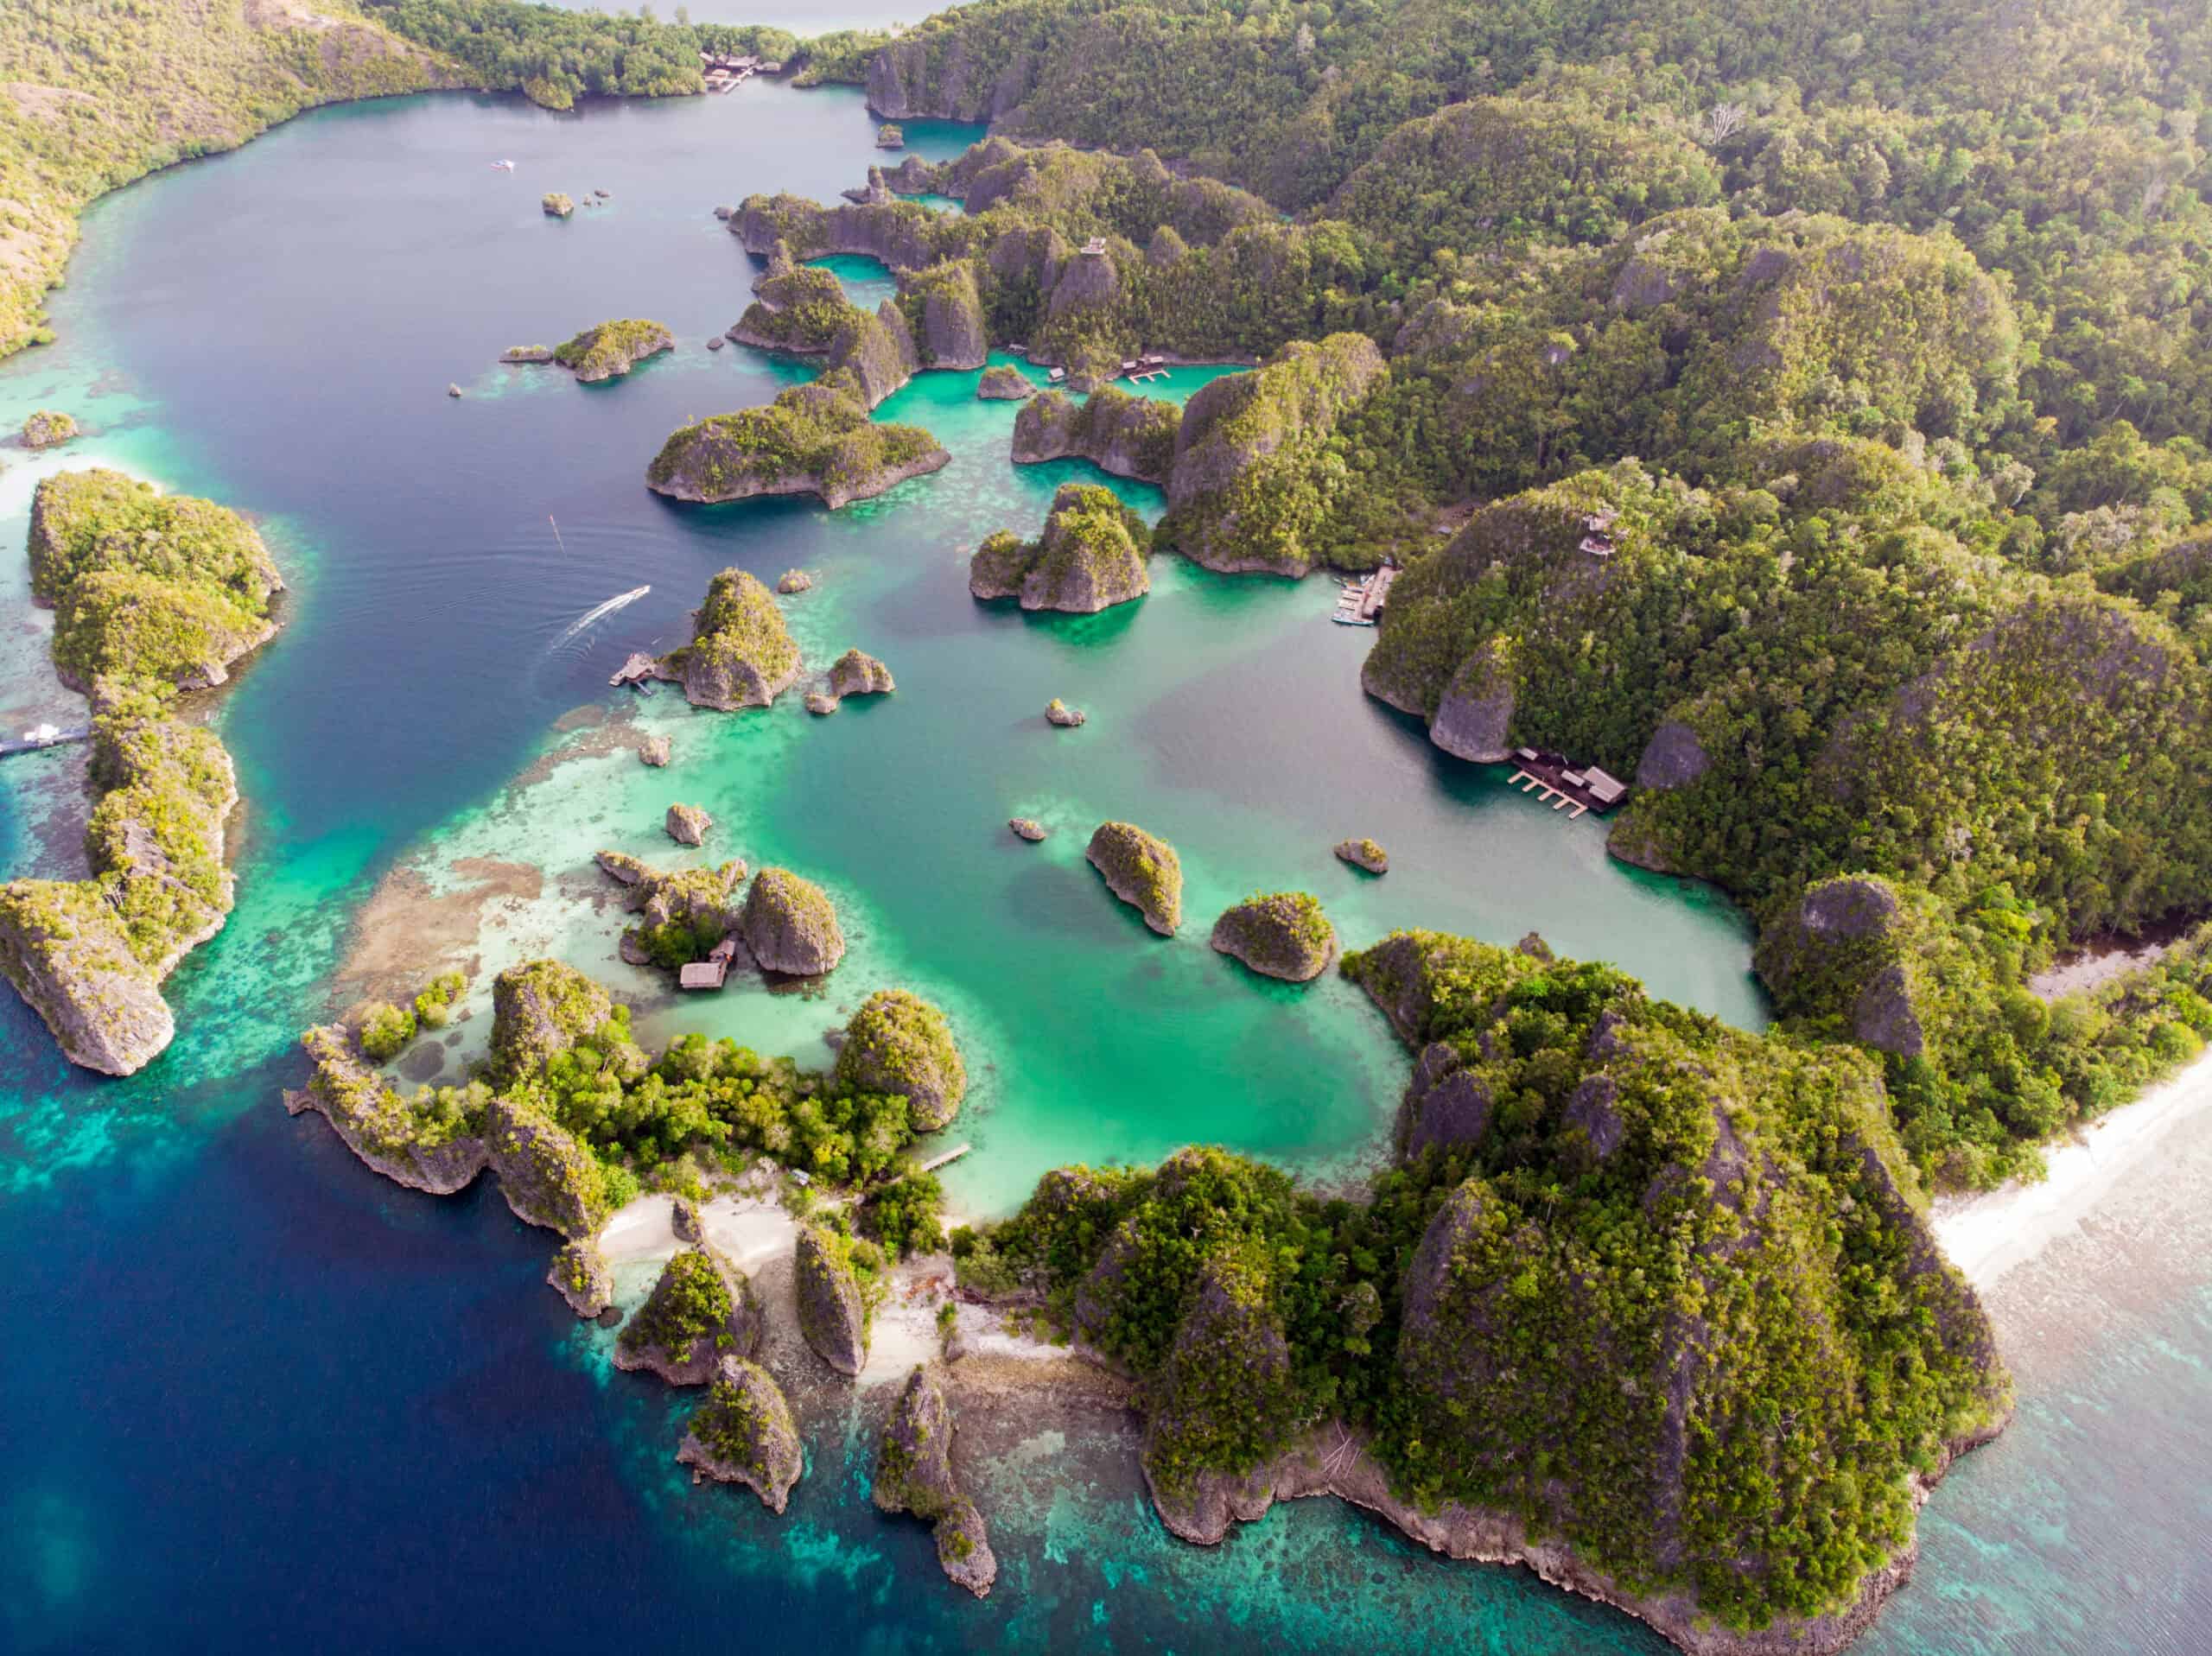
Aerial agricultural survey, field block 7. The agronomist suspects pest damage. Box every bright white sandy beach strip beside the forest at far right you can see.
[1936,1052,2212,1291]
